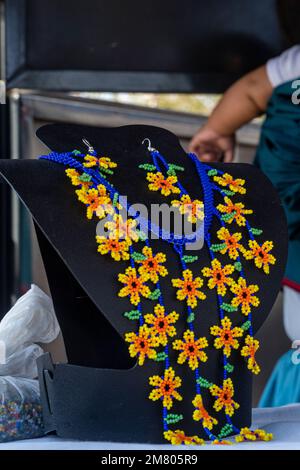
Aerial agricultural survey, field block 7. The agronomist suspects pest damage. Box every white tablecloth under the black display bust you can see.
[0,404,300,451]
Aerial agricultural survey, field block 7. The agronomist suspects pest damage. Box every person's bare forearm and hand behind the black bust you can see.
[189,66,273,162]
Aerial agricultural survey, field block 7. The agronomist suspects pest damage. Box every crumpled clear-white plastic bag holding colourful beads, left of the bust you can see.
[0,285,60,442]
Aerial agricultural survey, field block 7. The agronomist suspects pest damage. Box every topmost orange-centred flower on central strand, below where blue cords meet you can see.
[172,269,206,308]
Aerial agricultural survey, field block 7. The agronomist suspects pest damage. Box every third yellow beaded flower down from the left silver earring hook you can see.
[76,184,114,219]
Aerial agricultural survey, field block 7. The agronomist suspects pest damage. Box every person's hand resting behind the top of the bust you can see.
[189,126,235,163]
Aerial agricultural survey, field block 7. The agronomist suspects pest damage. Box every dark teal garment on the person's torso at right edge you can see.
[255,80,300,286]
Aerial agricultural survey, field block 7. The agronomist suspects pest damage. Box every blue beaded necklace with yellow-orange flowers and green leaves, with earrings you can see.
[40,139,276,445]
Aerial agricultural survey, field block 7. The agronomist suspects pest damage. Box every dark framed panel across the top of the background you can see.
[6,0,284,93]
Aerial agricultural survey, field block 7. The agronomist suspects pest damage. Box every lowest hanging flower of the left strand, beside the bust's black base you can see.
[149,367,182,410]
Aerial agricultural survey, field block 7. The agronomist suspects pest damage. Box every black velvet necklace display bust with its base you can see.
[0,124,287,443]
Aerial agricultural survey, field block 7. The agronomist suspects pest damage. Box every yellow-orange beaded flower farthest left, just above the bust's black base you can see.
[125,325,159,366]
